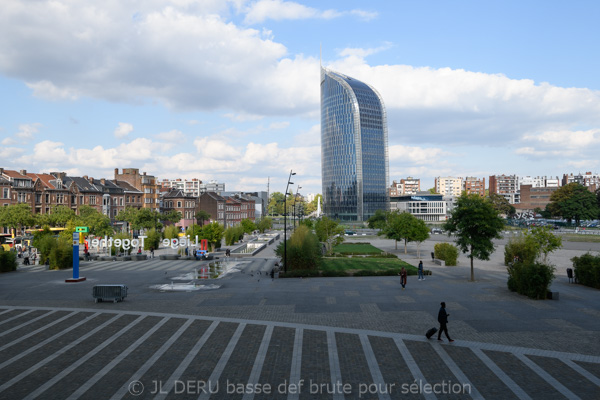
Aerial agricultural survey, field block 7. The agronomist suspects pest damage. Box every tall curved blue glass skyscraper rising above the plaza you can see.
[321,68,389,221]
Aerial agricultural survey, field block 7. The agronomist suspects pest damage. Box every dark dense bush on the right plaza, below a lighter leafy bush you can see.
[507,262,554,299]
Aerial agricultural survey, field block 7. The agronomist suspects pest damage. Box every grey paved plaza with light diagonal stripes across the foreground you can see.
[0,235,600,399]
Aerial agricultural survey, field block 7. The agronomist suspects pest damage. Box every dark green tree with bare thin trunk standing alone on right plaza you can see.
[444,194,504,281]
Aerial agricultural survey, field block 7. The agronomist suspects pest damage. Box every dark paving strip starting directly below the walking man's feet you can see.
[443,344,517,399]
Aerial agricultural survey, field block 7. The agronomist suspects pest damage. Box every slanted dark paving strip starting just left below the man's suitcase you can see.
[404,340,465,399]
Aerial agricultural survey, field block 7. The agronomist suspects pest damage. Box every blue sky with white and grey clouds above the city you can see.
[0,0,600,194]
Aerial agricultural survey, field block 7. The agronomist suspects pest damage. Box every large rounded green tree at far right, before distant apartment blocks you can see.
[548,183,599,226]
